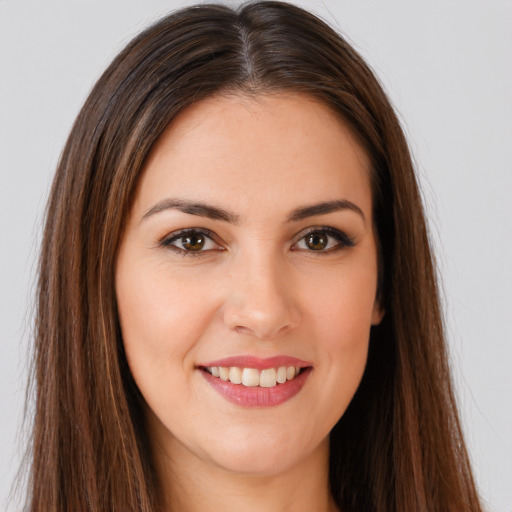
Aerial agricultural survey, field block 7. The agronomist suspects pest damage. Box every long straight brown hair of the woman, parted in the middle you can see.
[29,2,481,512]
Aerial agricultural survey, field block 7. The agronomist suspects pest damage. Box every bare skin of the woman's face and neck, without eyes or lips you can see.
[116,94,382,512]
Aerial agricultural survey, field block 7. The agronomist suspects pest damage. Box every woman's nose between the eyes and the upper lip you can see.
[223,252,300,340]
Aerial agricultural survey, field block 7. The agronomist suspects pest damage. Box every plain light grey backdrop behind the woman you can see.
[0,0,512,512]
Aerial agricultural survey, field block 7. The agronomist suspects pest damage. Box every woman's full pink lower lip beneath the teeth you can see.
[200,368,311,407]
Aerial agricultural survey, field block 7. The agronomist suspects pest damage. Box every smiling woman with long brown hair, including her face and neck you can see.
[30,2,480,511]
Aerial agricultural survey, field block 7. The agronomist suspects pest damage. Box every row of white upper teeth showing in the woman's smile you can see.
[200,366,307,388]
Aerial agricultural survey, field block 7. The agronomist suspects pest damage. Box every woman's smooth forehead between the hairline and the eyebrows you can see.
[136,93,371,218]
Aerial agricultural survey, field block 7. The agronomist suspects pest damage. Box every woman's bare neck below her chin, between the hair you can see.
[155,434,337,512]
